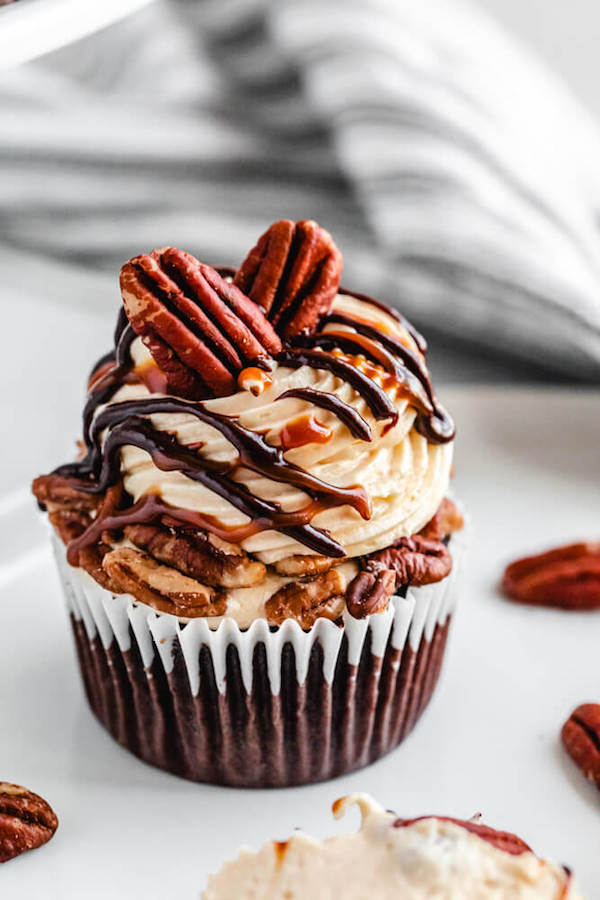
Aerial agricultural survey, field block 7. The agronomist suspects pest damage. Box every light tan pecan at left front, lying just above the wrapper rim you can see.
[102,547,226,618]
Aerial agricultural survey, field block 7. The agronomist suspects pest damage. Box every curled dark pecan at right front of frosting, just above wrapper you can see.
[346,534,452,619]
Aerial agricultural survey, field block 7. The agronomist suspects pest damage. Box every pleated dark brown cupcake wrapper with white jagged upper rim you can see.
[52,535,464,786]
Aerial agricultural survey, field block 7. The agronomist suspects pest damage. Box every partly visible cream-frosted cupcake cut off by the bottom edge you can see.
[202,794,581,900]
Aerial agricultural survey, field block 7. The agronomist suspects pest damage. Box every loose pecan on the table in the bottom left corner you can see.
[0,781,58,863]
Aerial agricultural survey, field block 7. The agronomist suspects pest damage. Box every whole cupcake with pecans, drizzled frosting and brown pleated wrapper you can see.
[33,221,462,786]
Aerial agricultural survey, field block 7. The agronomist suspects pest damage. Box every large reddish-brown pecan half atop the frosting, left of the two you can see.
[121,247,281,398]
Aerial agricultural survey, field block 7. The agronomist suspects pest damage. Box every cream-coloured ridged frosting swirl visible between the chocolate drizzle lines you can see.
[110,294,452,563]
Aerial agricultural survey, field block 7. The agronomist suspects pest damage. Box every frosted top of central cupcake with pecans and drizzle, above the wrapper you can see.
[34,221,461,627]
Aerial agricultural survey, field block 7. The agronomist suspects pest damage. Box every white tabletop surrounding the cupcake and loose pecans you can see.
[0,244,600,900]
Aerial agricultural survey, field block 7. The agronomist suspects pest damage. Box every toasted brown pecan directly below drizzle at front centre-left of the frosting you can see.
[124,525,266,588]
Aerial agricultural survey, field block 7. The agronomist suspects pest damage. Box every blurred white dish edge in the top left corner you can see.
[0,0,151,69]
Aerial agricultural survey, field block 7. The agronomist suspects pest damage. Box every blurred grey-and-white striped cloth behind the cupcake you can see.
[0,0,600,380]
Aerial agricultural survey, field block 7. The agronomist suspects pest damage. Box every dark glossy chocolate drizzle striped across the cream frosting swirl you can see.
[56,270,454,563]
